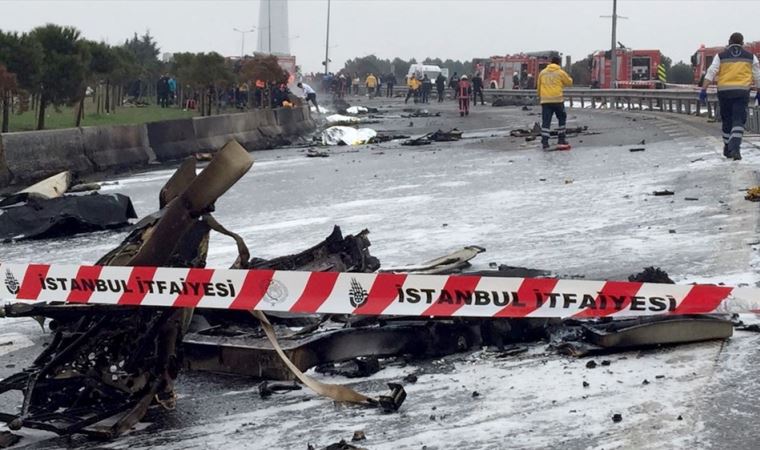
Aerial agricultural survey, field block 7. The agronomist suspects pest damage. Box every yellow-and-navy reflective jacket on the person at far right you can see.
[705,44,760,95]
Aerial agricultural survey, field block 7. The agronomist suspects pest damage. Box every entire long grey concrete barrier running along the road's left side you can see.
[0,106,315,186]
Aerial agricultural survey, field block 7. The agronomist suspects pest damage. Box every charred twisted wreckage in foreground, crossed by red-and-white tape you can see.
[0,141,732,438]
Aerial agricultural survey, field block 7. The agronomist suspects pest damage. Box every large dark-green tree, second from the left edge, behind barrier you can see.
[30,24,89,130]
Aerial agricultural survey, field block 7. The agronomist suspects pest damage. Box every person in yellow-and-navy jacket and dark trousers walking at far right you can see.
[699,33,760,161]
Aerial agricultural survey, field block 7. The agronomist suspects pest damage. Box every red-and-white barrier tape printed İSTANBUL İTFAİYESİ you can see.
[0,264,760,318]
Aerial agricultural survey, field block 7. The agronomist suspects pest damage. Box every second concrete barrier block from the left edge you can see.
[82,125,156,171]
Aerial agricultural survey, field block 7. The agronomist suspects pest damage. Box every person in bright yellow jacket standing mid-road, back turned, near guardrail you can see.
[536,56,573,150]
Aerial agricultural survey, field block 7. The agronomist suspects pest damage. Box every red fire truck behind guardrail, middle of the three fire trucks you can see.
[591,48,662,89]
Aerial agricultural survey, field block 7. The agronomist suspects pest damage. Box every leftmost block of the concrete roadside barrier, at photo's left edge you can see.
[0,128,94,183]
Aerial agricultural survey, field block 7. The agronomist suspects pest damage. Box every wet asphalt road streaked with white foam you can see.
[0,99,760,449]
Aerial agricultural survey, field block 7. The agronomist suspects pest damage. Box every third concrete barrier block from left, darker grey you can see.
[145,119,199,162]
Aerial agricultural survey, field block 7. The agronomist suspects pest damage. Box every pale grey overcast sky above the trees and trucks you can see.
[0,0,760,72]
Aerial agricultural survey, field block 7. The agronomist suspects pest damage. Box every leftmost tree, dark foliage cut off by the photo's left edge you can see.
[0,31,43,132]
